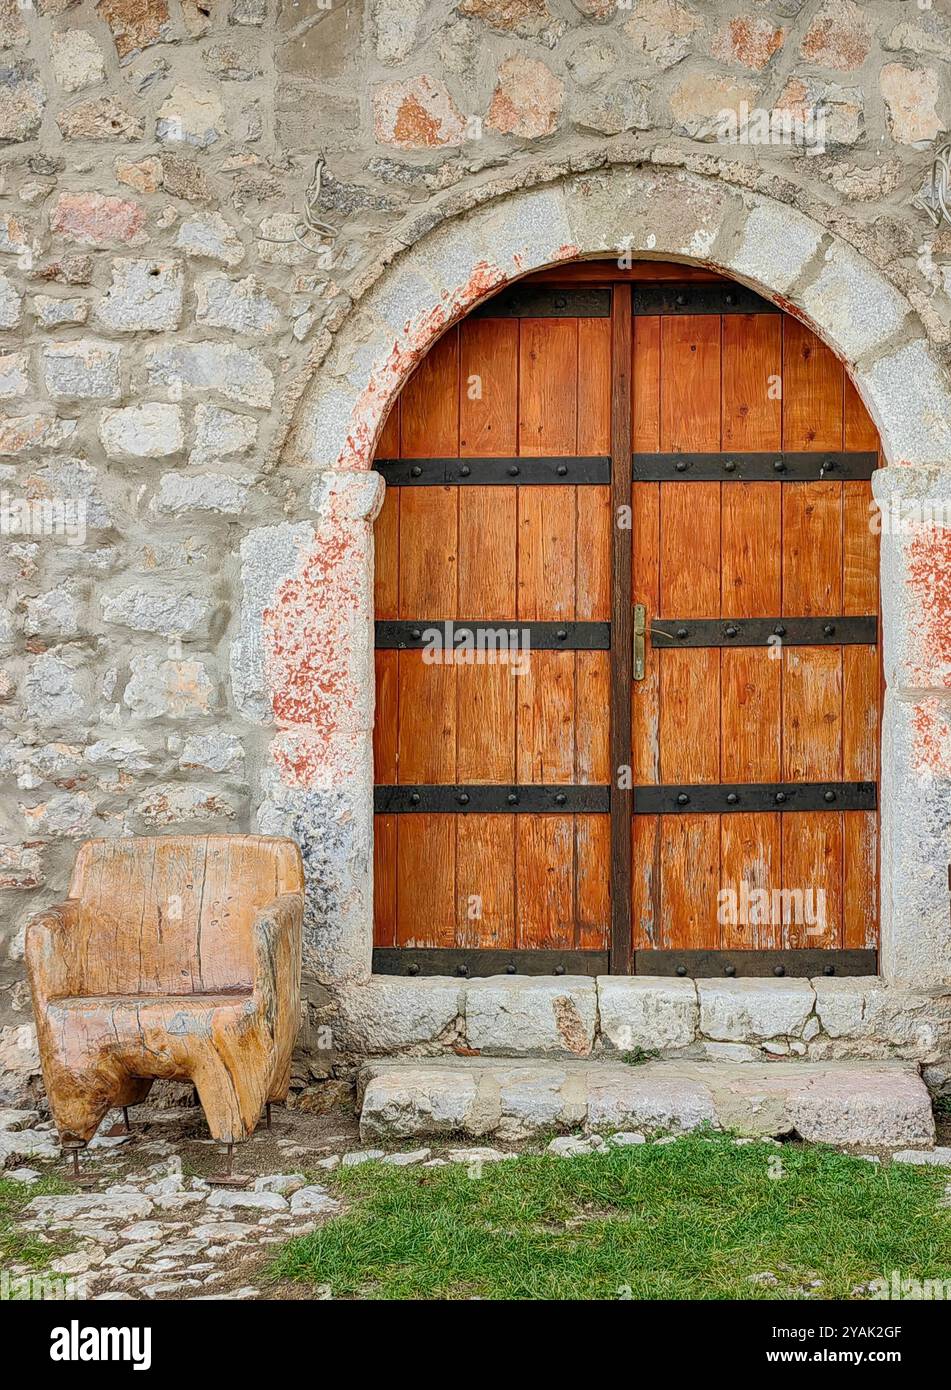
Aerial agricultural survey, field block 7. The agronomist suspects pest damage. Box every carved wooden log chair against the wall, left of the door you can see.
[26,835,303,1170]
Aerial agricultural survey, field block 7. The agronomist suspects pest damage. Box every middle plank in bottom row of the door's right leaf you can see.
[719,812,783,951]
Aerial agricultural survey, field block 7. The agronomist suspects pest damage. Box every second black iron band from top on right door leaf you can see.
[631,449,879,482]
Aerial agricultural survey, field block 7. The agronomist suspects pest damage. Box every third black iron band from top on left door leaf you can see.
[375,619,610,653]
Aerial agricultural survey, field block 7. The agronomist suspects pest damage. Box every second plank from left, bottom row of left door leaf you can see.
[396,815,459,948]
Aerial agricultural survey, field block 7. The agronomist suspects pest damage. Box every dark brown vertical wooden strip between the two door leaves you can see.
[610,285,634,974]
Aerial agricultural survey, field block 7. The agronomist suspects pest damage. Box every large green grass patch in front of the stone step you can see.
[271,1136,951,1300]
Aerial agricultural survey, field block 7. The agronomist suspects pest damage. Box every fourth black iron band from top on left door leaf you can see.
[373,783,610,816]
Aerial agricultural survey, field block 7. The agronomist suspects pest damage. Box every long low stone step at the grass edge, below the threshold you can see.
[357,1058,936,1150]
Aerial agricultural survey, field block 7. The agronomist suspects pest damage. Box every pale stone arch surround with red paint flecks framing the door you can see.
[234,168,951,1050]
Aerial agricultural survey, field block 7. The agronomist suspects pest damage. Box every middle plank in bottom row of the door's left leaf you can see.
[455,816,516,949]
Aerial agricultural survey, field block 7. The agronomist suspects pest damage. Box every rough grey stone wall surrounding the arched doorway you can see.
[0,0,951,1069]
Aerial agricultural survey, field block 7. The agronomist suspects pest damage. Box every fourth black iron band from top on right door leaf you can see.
[634,783,877,816]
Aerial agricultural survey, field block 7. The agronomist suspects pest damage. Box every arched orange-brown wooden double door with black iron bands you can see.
[374,263,880,974]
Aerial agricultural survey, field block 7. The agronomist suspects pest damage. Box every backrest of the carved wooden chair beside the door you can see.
[70,835,303,995]
